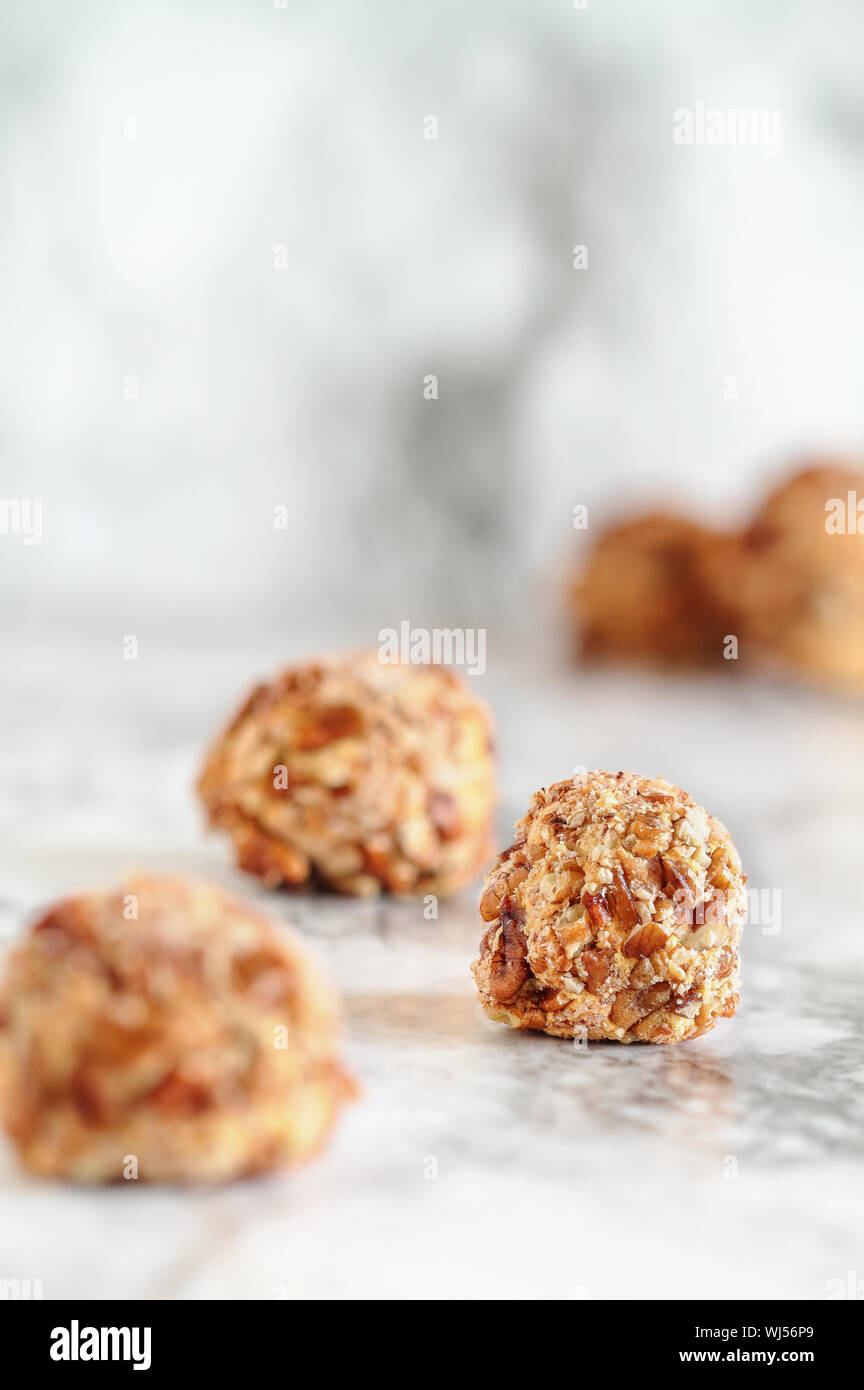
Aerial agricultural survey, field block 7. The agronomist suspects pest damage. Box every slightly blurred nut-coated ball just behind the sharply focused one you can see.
[199,652,495,894]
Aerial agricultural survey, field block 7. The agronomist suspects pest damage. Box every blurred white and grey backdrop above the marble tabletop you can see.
[0,0,864,645]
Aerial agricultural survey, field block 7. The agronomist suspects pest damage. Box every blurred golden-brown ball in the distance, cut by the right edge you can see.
[715,464,864,691]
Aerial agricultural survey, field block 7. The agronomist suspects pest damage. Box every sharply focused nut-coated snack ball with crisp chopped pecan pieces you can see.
[474,771,746,1043]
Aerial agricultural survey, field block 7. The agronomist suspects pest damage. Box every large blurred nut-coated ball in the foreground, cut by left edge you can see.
[0,878,353,1183]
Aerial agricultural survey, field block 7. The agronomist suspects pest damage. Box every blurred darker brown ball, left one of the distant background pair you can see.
[572,513,731,664]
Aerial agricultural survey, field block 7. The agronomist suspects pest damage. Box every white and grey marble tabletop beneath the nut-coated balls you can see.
[0,637,864,1298]
